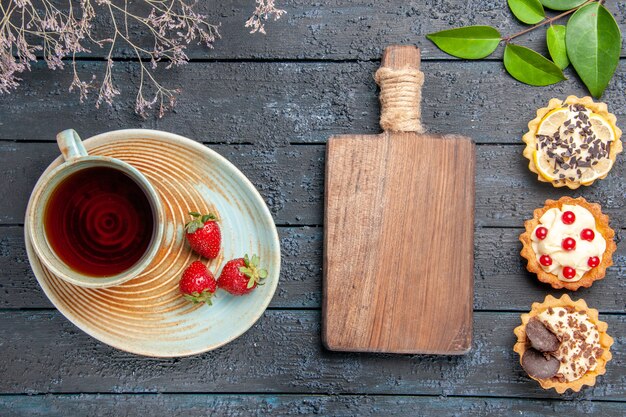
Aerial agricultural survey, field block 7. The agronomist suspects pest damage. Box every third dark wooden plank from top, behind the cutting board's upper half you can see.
[0,142,626,228]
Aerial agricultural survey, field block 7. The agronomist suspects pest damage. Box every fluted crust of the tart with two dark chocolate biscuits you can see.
[513,294,613,394]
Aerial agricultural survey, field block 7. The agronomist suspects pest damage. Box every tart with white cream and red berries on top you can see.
[520,197,617,291]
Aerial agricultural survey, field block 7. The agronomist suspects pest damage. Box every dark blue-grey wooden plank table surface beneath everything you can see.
[0,0,626,416]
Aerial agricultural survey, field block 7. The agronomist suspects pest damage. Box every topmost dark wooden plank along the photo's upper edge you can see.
[39,0,626,60]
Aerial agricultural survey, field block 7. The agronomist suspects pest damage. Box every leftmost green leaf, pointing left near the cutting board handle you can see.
[426,26,500,59]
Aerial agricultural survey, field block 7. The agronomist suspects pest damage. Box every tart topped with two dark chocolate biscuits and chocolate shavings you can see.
[513,295,613,394]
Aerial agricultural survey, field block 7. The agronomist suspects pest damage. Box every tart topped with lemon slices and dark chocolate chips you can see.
[522,96,622,189]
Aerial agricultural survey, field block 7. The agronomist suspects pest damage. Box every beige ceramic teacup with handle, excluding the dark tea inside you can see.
[25,129,164,288]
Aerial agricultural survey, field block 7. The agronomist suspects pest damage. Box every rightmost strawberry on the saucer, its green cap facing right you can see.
[217,255,267,295]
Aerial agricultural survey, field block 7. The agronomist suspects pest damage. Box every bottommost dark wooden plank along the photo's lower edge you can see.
[0,394,625,417]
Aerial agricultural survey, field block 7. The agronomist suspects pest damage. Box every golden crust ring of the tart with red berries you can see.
[519,197,617,291]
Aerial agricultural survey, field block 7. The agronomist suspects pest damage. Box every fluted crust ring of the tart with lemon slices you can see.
[522,96,623,190]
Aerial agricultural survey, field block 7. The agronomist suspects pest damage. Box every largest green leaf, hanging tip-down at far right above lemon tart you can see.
[565,3,622,98]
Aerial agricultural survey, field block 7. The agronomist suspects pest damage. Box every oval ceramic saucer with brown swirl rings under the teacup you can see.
[25,129,280,357]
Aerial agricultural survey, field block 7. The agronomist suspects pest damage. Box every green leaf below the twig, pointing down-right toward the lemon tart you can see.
[504,44,565,86]
